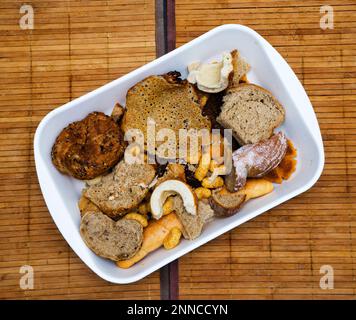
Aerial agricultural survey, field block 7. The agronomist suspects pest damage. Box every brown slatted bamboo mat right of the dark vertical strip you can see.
[176,0,356,299]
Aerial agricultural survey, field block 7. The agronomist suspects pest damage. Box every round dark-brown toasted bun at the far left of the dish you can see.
[52,112,126,180]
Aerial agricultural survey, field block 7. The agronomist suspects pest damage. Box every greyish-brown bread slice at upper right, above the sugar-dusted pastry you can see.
[217,84,285,145]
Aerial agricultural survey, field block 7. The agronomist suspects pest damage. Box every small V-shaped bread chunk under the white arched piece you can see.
[173,196,214,240]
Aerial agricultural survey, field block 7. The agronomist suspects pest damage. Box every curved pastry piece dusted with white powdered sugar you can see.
[225,132,287,192]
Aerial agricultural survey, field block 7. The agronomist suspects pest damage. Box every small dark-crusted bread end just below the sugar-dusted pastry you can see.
[209,188,246,217]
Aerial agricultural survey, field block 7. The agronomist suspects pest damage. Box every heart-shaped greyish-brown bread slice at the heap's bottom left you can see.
[80,211,143,261]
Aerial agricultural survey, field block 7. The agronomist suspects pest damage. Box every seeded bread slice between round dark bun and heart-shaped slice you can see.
[83,160,156,219]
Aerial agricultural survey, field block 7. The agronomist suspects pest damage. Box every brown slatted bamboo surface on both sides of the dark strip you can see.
[0,0,356,299]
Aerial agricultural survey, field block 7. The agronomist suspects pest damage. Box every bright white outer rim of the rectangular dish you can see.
[34,24,325,284]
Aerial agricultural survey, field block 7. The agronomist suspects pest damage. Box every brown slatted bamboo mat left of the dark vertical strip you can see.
[0,0,160,299]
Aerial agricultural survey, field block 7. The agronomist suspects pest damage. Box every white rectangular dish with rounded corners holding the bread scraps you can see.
[34,25,324,283]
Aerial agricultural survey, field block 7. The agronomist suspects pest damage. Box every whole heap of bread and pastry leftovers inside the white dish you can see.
[52,50,296,268]
